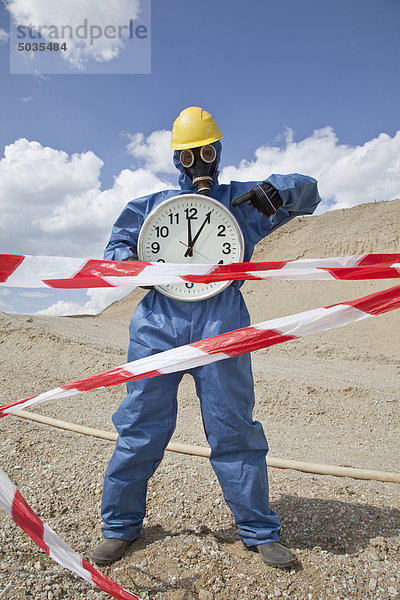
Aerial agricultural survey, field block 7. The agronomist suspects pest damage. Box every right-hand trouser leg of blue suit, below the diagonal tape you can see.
[192,354,280,546]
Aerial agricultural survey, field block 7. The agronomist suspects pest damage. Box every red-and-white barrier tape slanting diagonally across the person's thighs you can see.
[0,285,400,417]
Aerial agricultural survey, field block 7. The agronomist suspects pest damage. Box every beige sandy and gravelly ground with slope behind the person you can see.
[0,200,400,600]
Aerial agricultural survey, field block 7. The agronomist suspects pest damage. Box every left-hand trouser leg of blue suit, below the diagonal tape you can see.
[101,373,182,541]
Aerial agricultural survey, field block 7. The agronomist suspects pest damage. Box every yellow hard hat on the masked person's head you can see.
[171,106,223,150]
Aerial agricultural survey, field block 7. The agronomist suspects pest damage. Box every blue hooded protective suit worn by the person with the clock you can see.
[102,142,320,546]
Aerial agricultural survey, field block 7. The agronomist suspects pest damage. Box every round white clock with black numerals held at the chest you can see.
[138,194,244,300]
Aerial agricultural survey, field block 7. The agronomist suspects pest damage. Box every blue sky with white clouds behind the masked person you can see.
[0,0,400,314]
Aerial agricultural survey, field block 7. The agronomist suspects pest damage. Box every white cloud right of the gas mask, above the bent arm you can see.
[220,127,400,210]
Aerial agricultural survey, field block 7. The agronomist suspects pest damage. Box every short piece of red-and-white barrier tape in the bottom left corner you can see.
[0,469,140,600]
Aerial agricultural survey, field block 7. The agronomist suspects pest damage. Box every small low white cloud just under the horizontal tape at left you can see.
[35,288,130,317]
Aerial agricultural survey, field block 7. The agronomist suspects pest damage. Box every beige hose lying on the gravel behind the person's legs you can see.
[13,410,400,483]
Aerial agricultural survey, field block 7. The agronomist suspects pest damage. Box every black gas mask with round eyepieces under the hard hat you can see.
[179,144,217,195]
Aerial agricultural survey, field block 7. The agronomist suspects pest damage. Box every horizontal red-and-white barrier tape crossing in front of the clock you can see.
[0,254,400,289]
